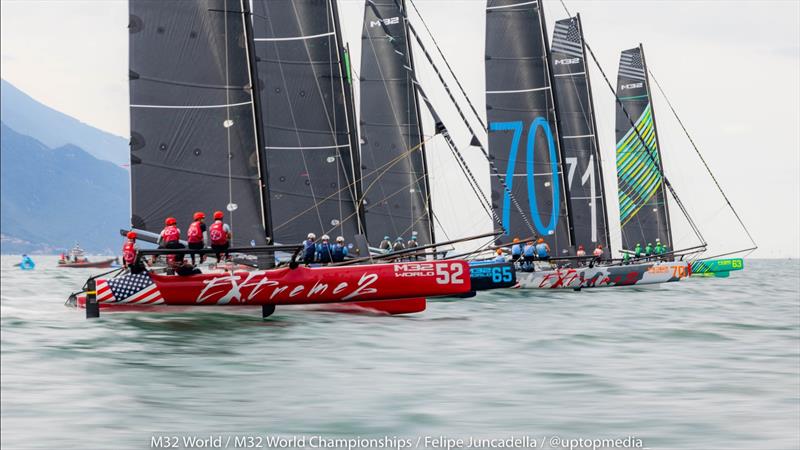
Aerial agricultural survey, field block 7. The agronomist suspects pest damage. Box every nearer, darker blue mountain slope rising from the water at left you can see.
[0,121,130,253]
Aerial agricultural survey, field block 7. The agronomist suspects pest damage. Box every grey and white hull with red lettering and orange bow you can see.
[517,261,691,289]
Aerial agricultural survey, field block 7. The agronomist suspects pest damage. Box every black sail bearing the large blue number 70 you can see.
[486,0,571,254]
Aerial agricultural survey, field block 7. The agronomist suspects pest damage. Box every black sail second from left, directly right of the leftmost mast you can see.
[253,0,363,243]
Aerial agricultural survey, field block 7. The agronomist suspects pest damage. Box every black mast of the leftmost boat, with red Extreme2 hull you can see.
[240,0,272,243]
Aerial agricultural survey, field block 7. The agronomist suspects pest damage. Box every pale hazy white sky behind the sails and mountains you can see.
[0,0,800,257]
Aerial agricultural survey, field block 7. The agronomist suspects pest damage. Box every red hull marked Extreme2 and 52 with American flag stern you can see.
[83,261,471,313]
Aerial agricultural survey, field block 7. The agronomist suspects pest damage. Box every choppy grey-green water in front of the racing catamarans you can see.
[0,256,800,449]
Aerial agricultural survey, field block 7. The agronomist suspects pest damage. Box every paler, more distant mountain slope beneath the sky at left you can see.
[0,80,129,165]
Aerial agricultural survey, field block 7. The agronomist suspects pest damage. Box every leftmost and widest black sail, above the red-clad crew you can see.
[129,0,266,245]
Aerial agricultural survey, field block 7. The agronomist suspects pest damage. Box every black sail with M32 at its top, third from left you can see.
[359,0,433,245]
